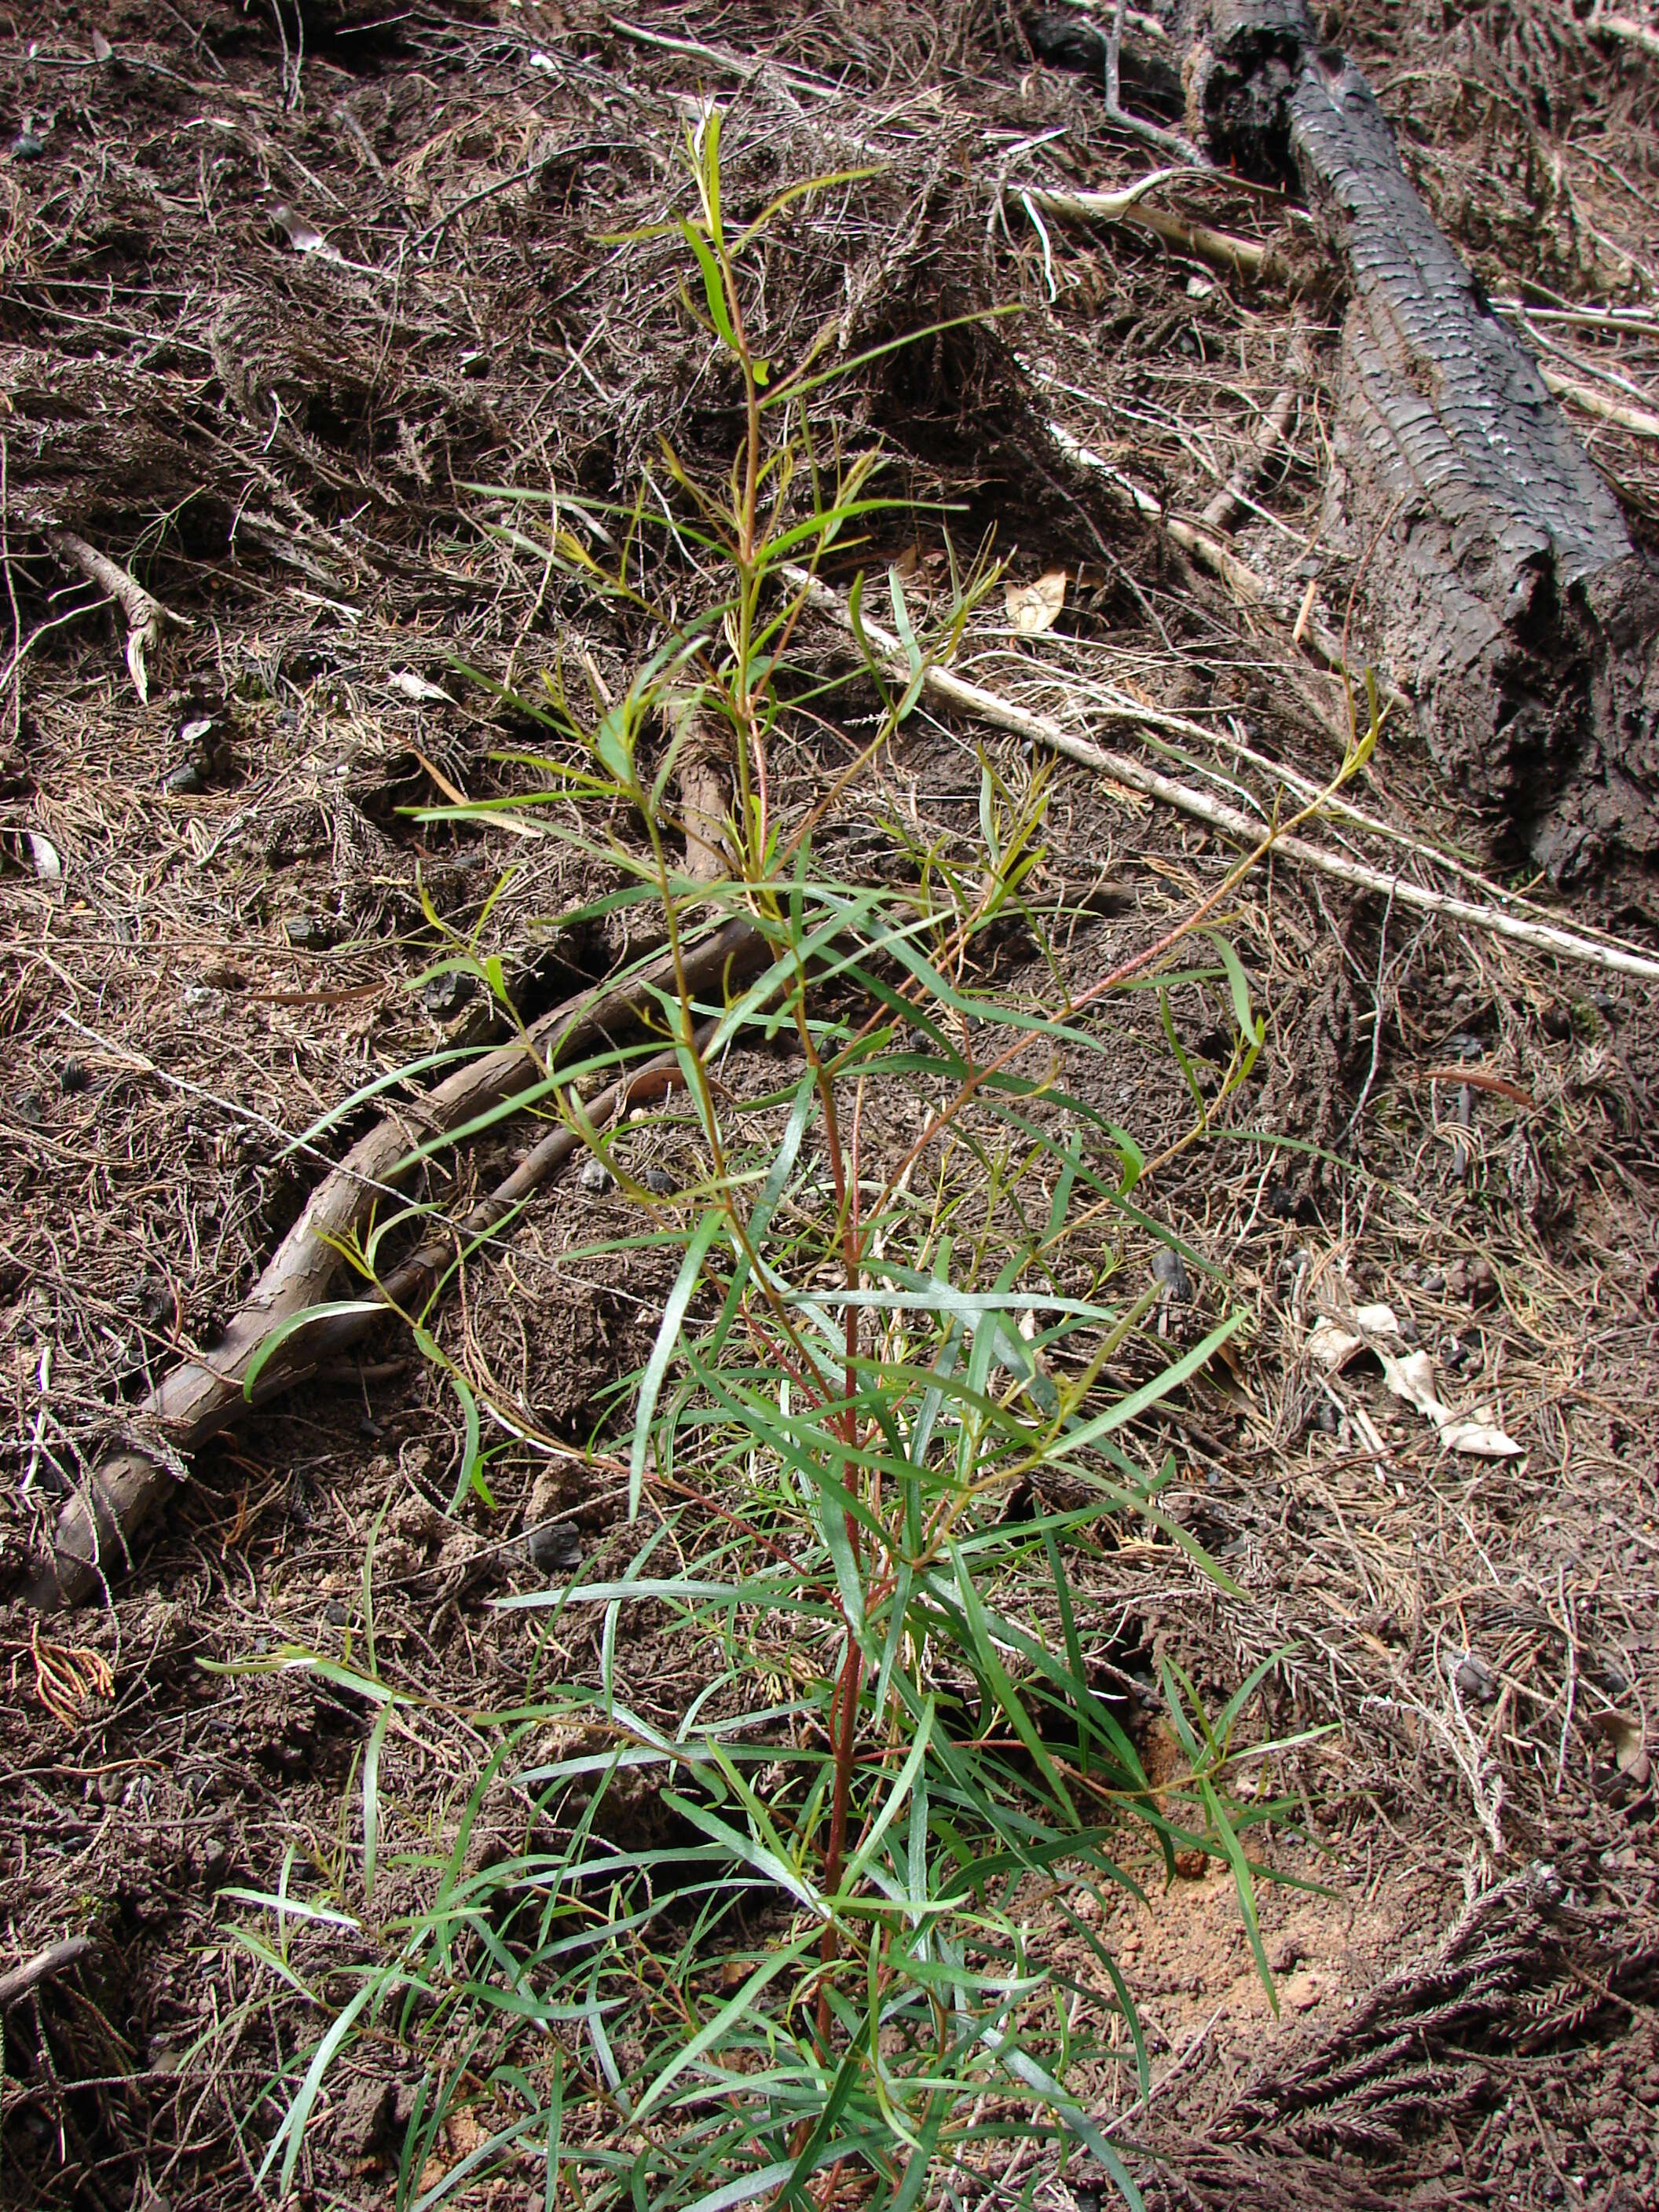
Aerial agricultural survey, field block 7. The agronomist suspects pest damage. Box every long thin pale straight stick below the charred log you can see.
[789,569,1659,982]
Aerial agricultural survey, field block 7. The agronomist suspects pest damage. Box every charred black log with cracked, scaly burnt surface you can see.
[1185,0,1659,881]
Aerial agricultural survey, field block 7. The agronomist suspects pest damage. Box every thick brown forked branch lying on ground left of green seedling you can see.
[29,920,764,1608]
